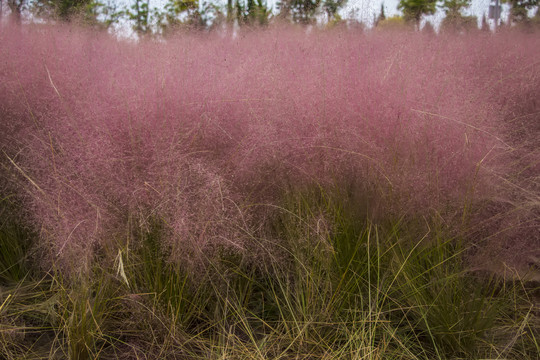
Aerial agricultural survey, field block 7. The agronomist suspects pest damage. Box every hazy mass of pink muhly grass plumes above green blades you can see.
[0,26,540,274]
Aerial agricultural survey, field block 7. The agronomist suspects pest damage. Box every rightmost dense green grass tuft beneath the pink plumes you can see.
[395,238,506,355]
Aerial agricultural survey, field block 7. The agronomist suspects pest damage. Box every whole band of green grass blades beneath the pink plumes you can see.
[0,186,538,360]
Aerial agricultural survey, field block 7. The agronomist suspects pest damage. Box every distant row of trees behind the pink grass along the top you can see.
[0,0,540,37]
